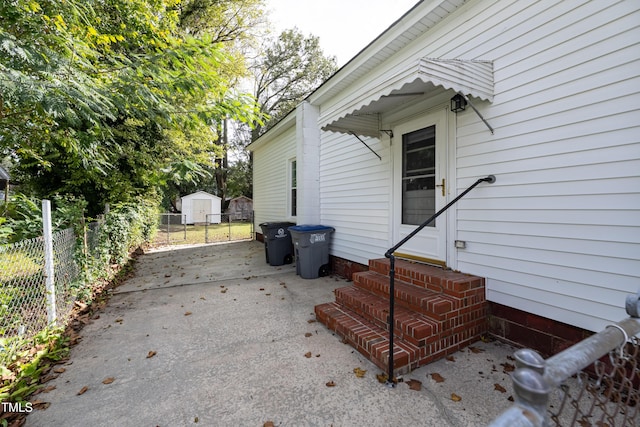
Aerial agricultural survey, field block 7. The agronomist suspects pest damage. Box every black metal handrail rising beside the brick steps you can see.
[384,175,496,387]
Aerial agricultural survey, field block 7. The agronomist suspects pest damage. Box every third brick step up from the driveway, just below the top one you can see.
[353,271,462,321]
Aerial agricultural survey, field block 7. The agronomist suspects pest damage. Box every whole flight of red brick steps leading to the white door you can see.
[315,259,487,375]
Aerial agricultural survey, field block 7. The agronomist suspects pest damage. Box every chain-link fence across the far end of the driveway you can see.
[154,212,254,246]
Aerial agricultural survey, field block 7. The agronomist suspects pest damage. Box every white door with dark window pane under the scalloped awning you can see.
[393,110,448,264]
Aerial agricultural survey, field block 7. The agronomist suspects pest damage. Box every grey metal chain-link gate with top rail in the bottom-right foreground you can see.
[489,293,640,427]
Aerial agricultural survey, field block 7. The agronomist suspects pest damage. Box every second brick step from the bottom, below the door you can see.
[335,286,442,347]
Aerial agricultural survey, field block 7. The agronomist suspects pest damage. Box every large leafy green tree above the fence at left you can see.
[0,0,260,214]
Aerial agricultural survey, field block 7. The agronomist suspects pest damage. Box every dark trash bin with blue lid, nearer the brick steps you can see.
[289,225,335,279]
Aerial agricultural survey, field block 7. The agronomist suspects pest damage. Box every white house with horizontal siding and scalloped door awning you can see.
[250,0,640,364]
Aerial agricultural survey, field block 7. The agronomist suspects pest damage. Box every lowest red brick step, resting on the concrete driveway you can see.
[315,302,421,375]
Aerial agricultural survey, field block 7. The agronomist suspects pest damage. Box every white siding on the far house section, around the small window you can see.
[253,127,296,230]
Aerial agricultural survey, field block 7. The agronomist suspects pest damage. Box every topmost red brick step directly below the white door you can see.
[369,258,484,298]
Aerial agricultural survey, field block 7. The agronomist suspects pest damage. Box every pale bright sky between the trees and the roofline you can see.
[265,0,418,67]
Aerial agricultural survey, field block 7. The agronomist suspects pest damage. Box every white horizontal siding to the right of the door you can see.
[441,1,640,331]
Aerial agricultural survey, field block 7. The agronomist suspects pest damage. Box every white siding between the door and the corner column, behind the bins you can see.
[320,132,391,264]
